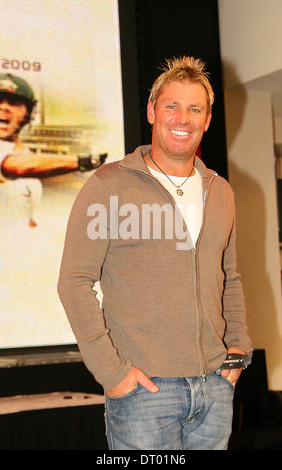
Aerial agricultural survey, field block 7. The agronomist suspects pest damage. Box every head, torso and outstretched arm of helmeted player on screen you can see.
[0,74,98,183]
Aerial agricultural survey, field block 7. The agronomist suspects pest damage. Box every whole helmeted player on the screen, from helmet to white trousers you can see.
[0,74,106,227]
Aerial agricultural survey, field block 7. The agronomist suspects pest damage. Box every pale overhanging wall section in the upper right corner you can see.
[218,0,282,88]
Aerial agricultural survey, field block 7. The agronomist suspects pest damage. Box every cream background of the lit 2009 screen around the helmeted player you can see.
[0,0,124,348]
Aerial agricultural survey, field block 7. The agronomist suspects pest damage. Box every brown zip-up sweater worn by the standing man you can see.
[58,146,252,390]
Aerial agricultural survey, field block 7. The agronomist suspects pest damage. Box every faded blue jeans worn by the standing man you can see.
[105,373,234,450]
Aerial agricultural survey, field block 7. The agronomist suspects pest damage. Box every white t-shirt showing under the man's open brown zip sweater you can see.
[149,168,203,245]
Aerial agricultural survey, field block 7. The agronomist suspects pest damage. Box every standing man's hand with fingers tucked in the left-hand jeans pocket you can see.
[106,366,159,397]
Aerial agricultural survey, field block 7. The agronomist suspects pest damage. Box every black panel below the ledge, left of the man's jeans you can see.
[0,405,107,450]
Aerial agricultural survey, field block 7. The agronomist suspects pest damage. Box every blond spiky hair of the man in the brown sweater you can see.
[149,56,214,111]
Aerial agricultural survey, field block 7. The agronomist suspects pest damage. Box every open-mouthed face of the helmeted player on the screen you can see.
[0,95,27,141]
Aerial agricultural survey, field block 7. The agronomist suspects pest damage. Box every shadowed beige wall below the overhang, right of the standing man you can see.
[225,91,282,390]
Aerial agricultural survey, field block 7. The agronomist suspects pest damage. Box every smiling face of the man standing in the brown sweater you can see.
[147,81,211,159]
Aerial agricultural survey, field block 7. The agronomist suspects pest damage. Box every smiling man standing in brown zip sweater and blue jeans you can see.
[58,57,252,450]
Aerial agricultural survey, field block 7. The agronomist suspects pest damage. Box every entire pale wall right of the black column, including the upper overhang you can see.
[218,0,282,390]
